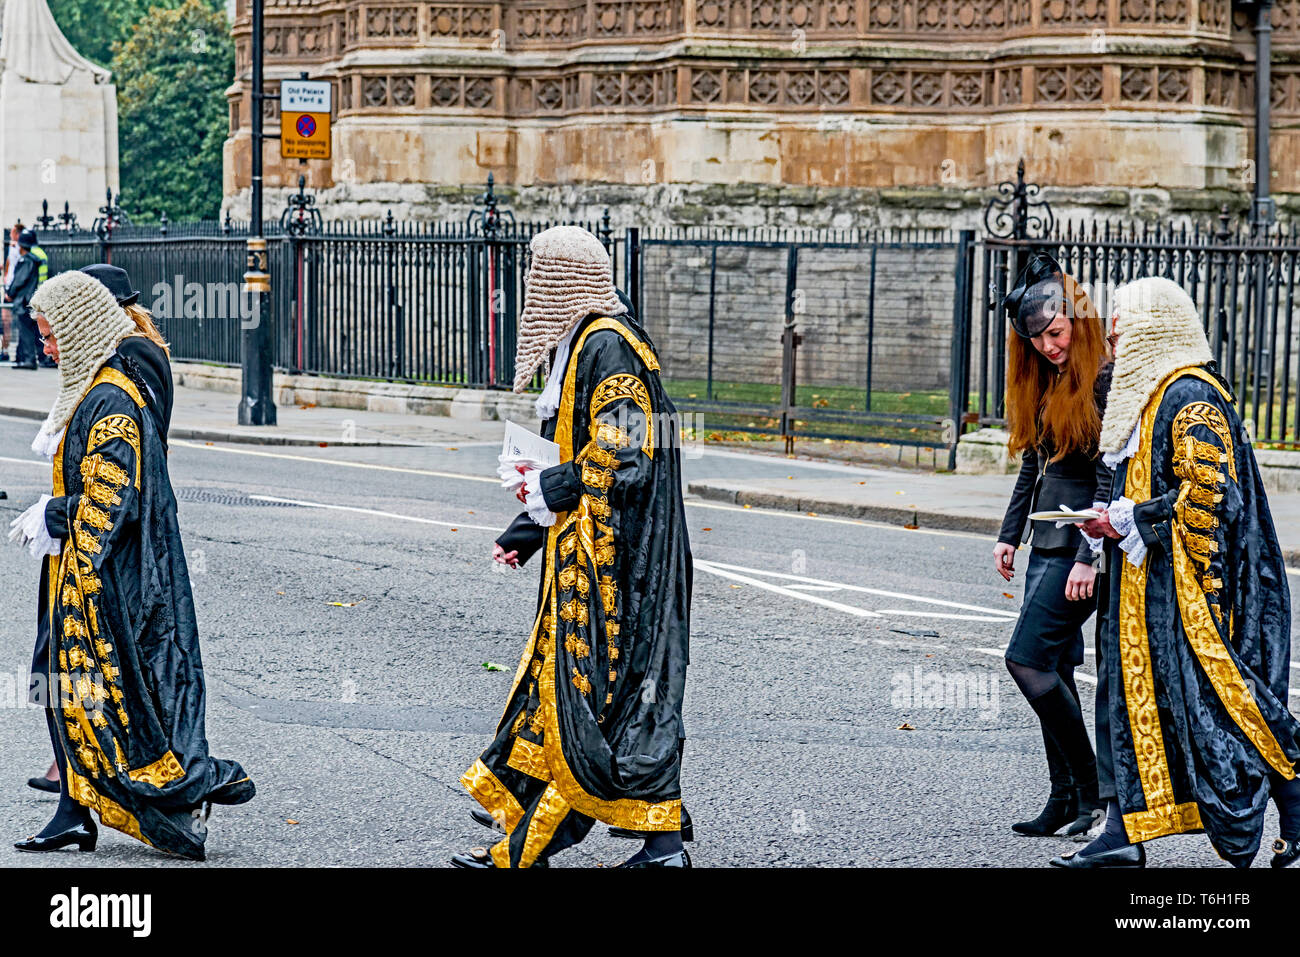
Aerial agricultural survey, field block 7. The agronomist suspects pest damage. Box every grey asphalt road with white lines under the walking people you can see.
[0,417,1297,867]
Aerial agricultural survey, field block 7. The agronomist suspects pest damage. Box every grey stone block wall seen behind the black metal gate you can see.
[642,243,956,398]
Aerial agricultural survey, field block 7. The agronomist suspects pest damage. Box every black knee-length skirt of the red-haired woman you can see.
[1006,549,1097,671]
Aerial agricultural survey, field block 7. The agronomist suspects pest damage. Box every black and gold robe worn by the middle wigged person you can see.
[462,316,692,867]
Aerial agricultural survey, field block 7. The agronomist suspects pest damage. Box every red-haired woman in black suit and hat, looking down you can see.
[993,254,1110,836]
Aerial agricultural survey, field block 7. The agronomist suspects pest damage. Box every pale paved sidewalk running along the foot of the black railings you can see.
[0,367,1300,566]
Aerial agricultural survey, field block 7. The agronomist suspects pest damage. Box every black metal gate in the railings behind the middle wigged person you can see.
[629,223,975,460]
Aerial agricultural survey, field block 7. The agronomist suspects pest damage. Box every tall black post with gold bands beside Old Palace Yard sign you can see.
[239,0,276,425]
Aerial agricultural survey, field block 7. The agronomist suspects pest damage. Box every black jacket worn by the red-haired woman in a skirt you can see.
[997,363,1113,563]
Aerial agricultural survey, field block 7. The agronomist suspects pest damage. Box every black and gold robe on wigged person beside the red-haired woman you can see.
[1102,367,1300,857]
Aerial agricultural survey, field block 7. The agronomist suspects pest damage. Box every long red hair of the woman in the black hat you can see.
[1006,276,1106,462]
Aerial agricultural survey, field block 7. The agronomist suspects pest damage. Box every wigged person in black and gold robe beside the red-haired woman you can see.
[1053,278,1300,866]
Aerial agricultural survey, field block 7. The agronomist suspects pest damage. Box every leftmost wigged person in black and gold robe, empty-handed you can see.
[17,273,254,861]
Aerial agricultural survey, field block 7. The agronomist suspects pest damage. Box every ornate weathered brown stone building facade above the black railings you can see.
[225,0,1300,226]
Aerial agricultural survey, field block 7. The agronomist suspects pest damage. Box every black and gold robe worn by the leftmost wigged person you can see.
[46,356,247,861]
